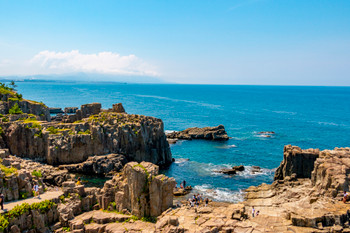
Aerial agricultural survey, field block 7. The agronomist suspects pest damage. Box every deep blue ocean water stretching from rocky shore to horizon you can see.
[17,82,350,202]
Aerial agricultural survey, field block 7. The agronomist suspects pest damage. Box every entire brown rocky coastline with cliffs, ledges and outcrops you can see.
[0,84,350,233]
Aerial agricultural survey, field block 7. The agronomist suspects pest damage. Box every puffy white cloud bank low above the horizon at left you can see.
[29,50,159,76]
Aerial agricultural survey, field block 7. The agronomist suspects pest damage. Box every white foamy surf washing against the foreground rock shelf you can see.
[193,184,244,203]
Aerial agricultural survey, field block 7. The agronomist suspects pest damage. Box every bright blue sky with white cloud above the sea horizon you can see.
[0,0,350,85]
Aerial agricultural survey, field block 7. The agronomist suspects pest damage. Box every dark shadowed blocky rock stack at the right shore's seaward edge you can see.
[275,145,320,180]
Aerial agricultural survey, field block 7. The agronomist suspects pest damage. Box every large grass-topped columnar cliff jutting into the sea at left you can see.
[0,105,172,166]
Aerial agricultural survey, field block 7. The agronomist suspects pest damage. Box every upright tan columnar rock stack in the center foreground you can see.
[99,162,175,217]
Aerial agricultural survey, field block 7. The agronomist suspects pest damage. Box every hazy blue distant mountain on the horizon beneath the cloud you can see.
[0,73,167,83]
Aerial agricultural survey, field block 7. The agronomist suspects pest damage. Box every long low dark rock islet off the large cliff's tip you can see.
[166,125,229,141]
